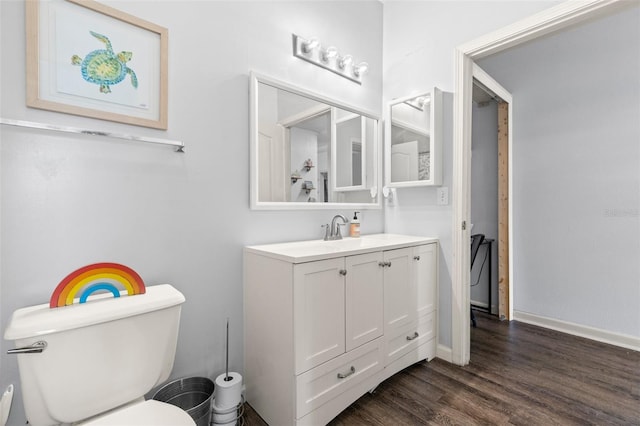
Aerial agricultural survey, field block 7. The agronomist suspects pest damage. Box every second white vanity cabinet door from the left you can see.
[345,252,384,351]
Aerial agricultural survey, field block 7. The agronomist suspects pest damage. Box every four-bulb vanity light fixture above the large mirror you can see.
[293,34,369,84]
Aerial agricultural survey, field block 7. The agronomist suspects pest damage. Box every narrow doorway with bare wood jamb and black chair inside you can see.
[469,64,513,320]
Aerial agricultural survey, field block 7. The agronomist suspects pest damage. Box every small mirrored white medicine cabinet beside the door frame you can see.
[385,88,442,188]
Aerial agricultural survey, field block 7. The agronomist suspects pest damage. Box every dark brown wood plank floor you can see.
[245,313,640,426]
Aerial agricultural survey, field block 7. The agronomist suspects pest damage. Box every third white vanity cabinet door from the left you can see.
[383,247,417,333]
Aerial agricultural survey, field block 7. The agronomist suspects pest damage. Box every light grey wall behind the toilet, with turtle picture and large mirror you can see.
[0,0,383,425]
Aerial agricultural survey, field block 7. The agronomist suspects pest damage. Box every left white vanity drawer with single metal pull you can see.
[296,338,384,419]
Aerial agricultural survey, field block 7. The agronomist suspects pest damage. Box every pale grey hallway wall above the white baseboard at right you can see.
[480,3,640,338]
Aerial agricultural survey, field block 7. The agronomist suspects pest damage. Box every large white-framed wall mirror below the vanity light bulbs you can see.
[251,73,380,209]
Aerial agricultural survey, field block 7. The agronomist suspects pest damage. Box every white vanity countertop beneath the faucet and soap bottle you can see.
[245,234,438,263]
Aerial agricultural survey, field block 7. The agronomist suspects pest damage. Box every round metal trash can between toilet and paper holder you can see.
[153,377,214,426]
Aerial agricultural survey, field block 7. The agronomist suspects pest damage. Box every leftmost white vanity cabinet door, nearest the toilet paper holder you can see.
[294,258,345,374]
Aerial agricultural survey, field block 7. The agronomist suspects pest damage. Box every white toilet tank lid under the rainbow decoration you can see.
[4,284,185,340]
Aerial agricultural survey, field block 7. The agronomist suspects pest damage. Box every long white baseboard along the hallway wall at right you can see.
[512,310,640,354]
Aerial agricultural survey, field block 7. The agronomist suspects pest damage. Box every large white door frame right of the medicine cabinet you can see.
[451,0,633,365]
